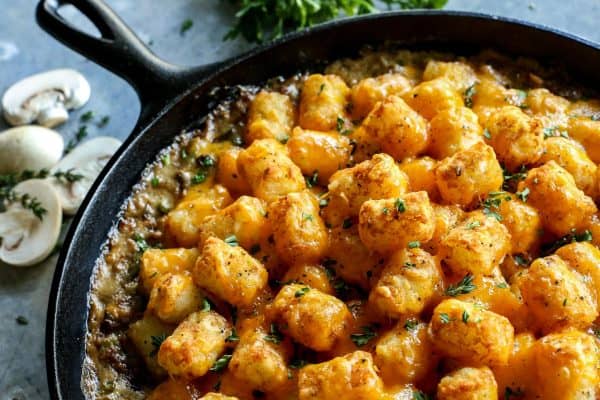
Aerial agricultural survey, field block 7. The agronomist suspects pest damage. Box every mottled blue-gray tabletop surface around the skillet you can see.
[0,0,600,400]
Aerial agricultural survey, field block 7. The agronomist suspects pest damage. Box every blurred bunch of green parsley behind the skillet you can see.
[225,0,448,43]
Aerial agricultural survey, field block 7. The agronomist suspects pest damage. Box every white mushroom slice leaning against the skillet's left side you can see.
[48,136,121,214]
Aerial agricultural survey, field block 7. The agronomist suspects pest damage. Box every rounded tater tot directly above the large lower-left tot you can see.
[148,274,203,323]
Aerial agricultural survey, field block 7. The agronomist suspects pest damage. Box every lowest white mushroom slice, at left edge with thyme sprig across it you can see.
[0,179,62,267]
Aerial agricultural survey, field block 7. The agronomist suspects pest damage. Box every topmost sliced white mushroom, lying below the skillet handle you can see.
[2,69,90,128]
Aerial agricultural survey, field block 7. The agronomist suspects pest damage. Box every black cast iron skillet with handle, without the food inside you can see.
[37,0,600,400]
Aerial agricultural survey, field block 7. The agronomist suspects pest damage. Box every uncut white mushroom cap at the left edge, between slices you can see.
[0,125,64,174]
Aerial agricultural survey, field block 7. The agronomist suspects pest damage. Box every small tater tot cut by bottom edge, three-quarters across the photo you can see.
[437,367,498,400]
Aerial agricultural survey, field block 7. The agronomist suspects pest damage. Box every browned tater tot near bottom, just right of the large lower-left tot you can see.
[228,327,291,391]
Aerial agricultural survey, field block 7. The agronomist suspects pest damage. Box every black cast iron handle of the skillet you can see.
[36,0,218,126]
